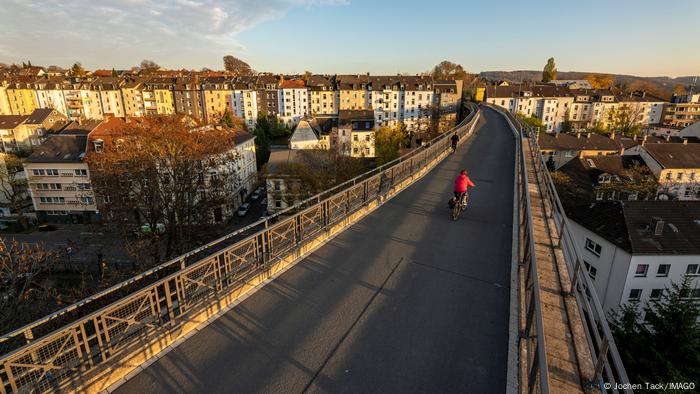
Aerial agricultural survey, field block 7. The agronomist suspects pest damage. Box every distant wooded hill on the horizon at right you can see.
[479,70,700,97]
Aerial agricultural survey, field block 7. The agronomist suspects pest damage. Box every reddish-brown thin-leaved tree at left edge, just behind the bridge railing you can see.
[0,239,59,332]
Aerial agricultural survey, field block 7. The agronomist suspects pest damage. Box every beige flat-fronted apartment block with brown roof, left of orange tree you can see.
[24,122,99,223]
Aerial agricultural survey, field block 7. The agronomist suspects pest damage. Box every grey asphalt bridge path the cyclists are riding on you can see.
[117,111,515,393]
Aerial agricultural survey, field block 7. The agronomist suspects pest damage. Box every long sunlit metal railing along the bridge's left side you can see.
[0,109,479,394]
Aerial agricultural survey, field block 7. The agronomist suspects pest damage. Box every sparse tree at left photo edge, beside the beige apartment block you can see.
[0,153,27,227]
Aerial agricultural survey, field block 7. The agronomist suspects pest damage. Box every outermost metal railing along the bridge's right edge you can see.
[501,106,632,393]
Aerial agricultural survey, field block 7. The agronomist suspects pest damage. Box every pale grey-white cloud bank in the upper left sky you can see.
[0,0,347,67]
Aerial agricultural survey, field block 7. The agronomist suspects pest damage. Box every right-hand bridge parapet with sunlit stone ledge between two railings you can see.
[491,107,631,393]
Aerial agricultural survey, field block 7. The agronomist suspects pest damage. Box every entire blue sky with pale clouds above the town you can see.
[0,0,700,76]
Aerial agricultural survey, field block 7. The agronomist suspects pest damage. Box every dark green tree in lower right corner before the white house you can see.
[609,276,700,393]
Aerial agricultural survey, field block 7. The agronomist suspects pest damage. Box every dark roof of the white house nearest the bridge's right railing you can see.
[567,201,700,255]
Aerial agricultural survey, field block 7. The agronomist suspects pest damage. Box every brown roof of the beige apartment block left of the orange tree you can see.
[27,134,87,163]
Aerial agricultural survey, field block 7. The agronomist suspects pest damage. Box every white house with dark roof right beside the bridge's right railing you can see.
[567,201,700,312]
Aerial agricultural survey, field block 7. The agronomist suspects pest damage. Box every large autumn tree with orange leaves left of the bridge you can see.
[88,115,245,268]
